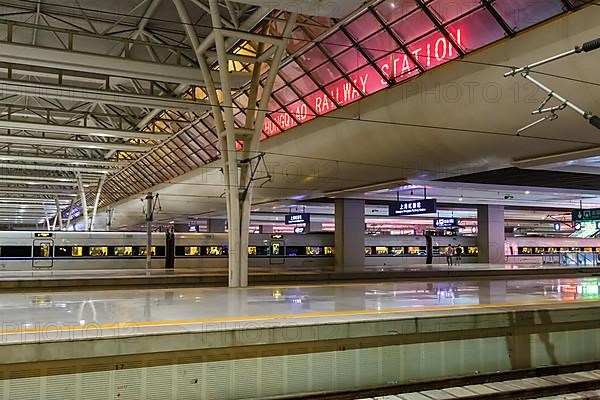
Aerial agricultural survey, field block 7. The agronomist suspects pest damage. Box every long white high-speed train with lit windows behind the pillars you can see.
[0,231,600,272]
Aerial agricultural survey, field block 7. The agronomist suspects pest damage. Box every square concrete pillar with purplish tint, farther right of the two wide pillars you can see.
[477,205,505,264]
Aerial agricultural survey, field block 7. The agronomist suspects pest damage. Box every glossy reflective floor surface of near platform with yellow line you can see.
[0,278,600,343]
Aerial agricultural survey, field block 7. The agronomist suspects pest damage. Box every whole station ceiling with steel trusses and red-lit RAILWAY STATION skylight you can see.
[0,0,600,225]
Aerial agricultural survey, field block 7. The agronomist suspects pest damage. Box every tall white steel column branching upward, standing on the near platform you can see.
[173,0,297,287]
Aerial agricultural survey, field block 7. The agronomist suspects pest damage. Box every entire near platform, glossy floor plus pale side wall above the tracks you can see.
[0,278,600,399]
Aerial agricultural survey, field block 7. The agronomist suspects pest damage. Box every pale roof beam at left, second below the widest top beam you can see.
[0,120,171,142]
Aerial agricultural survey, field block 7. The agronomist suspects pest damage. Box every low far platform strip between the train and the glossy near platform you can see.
[0,264,600,291]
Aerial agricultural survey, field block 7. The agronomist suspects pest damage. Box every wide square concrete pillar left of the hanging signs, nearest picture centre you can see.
[335,199,365,272]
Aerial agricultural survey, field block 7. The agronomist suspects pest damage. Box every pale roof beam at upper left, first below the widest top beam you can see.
[0,79,210,112]
